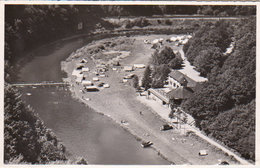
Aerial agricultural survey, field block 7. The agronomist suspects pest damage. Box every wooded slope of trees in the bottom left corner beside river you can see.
[4,85,86,164]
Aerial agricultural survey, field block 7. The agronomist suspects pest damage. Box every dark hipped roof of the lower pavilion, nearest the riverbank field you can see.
[167,87,193,99]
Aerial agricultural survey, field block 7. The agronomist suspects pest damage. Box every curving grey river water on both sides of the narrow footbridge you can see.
[18,33,169,165]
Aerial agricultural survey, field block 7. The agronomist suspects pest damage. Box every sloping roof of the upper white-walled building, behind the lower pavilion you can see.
[169,70,197,88]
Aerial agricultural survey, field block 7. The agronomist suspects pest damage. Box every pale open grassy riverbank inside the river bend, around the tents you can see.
[61,35,240,165]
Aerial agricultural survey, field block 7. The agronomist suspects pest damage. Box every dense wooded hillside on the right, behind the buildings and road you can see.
[183,17,256,160]
